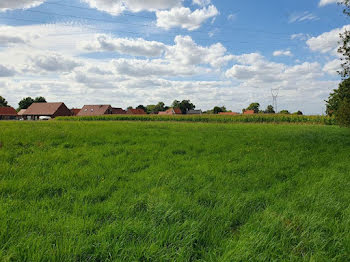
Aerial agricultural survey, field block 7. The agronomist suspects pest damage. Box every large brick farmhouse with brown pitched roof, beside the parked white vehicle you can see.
[22,102,72,120]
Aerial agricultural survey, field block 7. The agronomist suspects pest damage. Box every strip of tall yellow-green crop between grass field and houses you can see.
[57,114,335,125]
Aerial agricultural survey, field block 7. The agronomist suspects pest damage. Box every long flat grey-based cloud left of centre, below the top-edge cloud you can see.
[81,35,166,57]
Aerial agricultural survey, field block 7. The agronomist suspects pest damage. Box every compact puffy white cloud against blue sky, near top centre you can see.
[156,5,219,31]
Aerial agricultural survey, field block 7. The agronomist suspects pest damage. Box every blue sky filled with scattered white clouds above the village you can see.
[0,0,350,114]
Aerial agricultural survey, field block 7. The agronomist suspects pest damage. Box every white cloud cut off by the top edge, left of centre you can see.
[82,0,183,15]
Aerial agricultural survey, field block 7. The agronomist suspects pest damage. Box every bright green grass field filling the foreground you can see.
[0,121,350,261]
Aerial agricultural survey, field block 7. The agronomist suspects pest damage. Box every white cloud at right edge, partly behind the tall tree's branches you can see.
[306,25,350,55]
